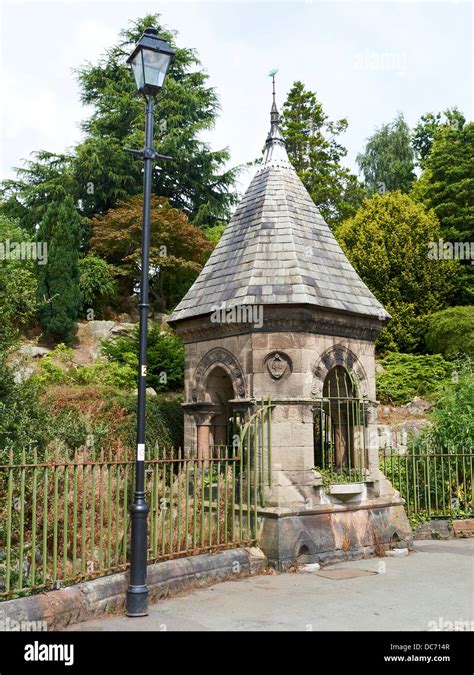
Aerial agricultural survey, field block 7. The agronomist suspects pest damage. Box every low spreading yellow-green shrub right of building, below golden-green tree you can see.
[377,352,453,404]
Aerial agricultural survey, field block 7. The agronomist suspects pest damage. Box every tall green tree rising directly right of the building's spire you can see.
[281,82,364,226]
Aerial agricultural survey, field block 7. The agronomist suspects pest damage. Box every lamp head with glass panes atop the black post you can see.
[127,28,175,96]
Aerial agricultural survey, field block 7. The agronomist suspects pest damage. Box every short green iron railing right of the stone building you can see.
[380,448,474,517]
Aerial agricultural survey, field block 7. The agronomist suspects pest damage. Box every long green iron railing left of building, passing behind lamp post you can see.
[0,403,271,599]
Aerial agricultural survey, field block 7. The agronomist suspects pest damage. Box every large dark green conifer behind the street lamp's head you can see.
[0,15,237,239]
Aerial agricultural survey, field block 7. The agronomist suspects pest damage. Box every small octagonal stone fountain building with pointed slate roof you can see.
[169,90,411,568]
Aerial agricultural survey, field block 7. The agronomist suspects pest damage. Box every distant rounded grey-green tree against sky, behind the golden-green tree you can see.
[357,113,415,194]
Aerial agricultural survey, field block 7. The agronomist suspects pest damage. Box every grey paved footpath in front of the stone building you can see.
[69,539,474,631]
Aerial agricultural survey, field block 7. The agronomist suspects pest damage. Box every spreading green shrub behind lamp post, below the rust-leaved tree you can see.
[102,324,184,391]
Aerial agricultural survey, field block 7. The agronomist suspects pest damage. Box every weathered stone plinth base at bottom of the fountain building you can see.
[259,499,413,570]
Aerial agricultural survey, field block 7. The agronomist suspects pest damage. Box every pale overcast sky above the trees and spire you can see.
[0,0,473,195]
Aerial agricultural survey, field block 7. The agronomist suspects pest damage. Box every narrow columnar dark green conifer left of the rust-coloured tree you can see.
[38,197,81,342]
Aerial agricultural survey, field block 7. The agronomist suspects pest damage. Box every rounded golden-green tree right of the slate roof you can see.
[336,191,457,352]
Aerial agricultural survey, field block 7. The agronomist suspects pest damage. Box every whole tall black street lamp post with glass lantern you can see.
[126,28,174,616]
